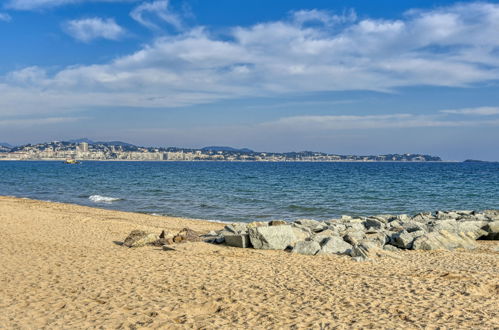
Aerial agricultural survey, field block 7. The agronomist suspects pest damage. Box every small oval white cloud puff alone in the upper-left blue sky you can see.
[63,17,125,42]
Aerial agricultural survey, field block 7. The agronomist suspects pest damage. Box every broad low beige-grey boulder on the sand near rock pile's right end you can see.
[412,230,476,250]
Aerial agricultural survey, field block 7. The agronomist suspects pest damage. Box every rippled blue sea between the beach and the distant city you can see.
[0,162,499,221]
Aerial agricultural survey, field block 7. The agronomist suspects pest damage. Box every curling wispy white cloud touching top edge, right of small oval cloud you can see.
[130,0,182,30]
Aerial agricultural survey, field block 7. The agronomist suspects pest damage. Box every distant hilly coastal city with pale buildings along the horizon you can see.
[0,139,442,162]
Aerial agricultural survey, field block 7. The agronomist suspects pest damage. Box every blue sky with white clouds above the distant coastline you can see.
[0,0,499,160]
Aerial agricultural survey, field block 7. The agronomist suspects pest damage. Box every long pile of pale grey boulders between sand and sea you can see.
[204,210,499,260]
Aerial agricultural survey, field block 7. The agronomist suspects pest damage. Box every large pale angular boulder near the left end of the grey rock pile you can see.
[248,225,297,250]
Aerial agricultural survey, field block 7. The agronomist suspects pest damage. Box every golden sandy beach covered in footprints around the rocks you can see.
[0,197,499,329]
